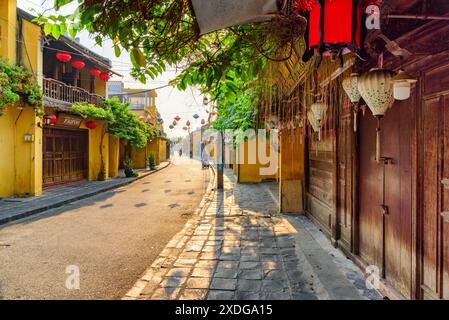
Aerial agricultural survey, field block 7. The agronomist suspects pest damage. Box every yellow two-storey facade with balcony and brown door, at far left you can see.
[0,0,119,197]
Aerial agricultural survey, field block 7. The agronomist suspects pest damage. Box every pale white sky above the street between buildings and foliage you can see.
[17,0,210,137]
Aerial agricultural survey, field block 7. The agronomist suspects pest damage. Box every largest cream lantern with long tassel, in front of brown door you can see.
[358,68,394,162]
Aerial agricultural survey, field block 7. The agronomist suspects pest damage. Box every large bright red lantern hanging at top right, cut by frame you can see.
[305,0,362,60]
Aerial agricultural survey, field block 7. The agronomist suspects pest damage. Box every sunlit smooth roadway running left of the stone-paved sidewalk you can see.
[0,157,209,299]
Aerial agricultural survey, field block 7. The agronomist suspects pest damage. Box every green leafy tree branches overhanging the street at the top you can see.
[36,0,304,130]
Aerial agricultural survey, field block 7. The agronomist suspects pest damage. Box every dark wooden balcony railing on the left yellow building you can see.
[43,78,104,105]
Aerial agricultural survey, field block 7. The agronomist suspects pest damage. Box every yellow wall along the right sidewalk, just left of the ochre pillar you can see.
[237,140,278,183]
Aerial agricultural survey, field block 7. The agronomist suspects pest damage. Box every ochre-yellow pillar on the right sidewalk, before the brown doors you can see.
[279,128,305,213]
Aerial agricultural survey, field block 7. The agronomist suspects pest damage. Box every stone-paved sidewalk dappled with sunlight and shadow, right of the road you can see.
[124,172,381,300]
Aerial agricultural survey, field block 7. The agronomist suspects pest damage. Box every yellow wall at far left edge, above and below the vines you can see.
[0,0,42,197]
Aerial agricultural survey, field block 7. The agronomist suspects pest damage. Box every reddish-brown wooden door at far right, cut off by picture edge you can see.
[421,95,449,299]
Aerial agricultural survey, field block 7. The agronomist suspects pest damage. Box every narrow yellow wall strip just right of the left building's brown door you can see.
[80,119,109,181]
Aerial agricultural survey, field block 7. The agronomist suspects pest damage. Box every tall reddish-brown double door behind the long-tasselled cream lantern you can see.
[359,101,415,298]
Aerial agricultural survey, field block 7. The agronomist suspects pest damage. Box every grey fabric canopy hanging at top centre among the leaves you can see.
[191,0,279,35]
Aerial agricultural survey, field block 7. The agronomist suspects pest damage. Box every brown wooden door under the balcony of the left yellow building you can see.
[43,128,87,187]
